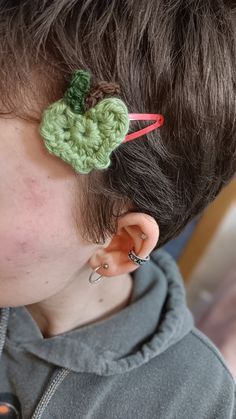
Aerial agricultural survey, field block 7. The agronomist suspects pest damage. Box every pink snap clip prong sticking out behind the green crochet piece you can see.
[122,113,165,143]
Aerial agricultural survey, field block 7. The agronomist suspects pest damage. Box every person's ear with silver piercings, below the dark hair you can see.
[89,212,159,276]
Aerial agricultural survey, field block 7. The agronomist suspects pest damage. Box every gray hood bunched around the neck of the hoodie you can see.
[0,250,193,376]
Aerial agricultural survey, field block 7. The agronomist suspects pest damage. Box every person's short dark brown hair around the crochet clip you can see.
[0,0,236,246]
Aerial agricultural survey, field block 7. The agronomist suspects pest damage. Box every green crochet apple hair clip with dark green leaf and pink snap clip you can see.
[40,70,164,173]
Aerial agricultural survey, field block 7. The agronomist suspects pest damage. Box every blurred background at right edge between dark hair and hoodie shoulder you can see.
[164,178,236,376]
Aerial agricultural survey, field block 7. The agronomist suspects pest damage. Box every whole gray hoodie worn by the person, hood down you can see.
[0,250,236,419]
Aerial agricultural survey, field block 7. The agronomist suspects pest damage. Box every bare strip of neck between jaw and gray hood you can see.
[26,273,133,338]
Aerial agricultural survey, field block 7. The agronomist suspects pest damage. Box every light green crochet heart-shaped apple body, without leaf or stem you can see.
[40,98,129,173]
